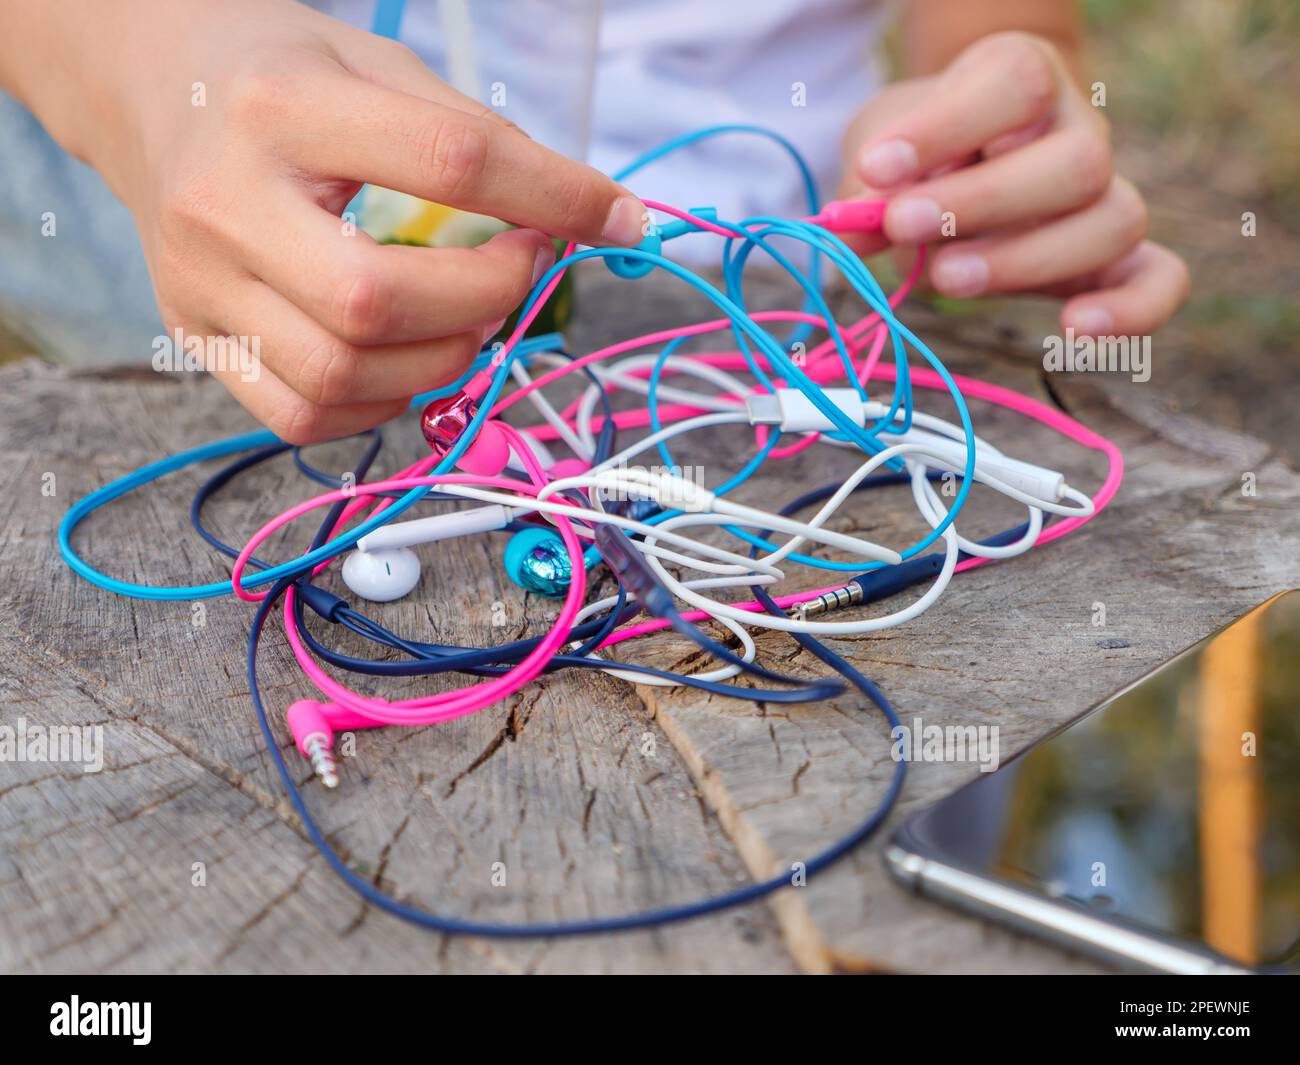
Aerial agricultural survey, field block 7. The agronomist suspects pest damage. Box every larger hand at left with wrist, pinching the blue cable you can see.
[22,0,644,443]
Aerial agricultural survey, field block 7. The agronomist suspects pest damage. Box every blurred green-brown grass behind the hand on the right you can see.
[1084,0,1300,466]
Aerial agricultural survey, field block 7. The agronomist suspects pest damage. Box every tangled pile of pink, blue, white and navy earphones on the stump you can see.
[59,126,1123,938]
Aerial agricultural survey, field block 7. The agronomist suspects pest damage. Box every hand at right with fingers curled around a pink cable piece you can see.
[844,33,1188,335]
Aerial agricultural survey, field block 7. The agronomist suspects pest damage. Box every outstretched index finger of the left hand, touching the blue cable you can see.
[282,67,646,247]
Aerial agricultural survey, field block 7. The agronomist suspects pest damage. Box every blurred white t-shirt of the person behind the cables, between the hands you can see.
[316,0,888,218]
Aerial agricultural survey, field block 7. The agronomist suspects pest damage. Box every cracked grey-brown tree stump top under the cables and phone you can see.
[0,272,1300,973]
